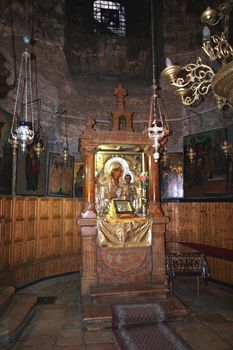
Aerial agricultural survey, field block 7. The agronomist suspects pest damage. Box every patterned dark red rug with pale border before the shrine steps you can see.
[112,303,190,350]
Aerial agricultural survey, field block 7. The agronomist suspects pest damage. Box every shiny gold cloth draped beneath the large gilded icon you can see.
[97,217,152,248]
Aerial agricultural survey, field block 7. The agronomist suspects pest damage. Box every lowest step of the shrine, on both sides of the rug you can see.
[83,296,191,330]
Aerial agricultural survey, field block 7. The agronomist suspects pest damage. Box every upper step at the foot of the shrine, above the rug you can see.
[90,282,169,304]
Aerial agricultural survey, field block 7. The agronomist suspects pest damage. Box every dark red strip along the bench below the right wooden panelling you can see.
[178,242,233,261]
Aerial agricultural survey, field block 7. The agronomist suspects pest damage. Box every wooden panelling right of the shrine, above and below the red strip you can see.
[163,202,233,284]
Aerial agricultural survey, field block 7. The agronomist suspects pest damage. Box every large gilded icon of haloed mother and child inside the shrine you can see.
[95,151,146,216]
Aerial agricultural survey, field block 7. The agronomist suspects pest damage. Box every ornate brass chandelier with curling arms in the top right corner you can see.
[161,0,233,110]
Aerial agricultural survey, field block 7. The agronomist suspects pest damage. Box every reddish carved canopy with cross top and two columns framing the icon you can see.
[80,85,165,218]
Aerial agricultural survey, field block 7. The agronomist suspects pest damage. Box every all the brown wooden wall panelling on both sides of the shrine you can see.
[0,197,233,287]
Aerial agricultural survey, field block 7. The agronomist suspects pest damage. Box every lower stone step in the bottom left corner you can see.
[0,294,37,350]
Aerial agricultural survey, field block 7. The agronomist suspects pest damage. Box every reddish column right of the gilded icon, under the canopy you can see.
[148,148,164,217]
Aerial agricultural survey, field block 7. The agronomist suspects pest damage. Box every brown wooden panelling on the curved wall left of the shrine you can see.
[0,197,82,287]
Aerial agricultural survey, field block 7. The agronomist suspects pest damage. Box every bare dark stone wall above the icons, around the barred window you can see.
[0,0,231,159]
